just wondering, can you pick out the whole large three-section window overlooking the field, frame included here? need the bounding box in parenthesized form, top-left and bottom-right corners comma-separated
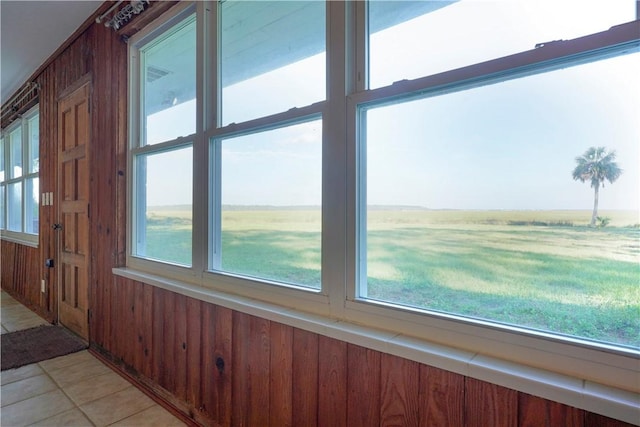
(126, 0, 640, 408)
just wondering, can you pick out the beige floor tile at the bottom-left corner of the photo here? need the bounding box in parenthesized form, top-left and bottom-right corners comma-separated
(0, 390, 73, 426)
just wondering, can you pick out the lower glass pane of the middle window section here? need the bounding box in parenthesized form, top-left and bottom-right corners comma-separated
(220, 120, 322, 289)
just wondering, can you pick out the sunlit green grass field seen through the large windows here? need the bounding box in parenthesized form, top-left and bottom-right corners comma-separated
(142, 208, 640, 347)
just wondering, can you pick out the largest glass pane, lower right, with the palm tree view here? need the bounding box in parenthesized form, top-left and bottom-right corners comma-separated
(360, 53, 640, 348)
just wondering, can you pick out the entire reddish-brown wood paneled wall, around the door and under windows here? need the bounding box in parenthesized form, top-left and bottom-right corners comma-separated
(2, 4, 636, 426)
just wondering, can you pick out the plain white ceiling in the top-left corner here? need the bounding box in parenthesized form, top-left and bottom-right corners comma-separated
(0, 0, 102, 104)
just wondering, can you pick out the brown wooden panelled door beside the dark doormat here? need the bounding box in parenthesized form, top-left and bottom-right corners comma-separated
(54, 83, 90, 340)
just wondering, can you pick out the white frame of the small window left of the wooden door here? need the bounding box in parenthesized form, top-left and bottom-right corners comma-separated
(0, 105, 40, 247)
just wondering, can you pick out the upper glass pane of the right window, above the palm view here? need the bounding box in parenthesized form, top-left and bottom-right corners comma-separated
(369, 0, 636, 88)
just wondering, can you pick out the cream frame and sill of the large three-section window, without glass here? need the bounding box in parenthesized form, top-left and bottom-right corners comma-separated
(114, 1, 640, 422)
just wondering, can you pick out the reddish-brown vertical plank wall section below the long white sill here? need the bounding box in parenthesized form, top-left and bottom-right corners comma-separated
(92, 278, 626, 427)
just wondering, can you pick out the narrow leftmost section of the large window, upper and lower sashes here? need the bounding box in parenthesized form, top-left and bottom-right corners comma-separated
(131, 11, 196, 267)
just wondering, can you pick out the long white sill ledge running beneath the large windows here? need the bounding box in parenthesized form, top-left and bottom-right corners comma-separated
(113, 268, 640, 424)
